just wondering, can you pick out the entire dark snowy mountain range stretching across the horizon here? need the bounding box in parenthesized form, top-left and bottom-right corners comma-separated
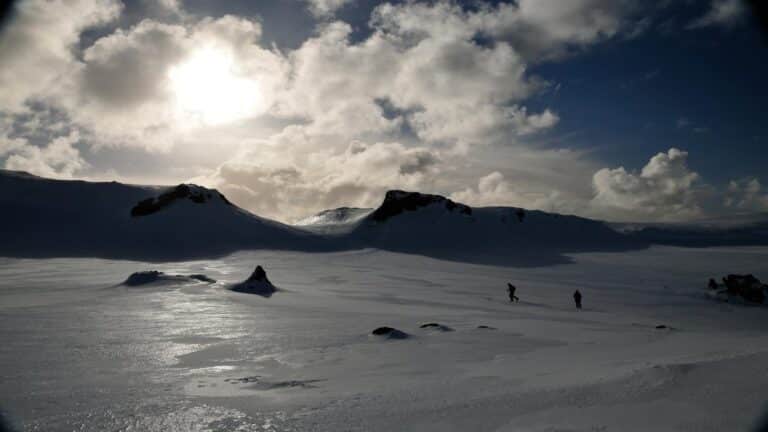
(0, 171, 768, 265)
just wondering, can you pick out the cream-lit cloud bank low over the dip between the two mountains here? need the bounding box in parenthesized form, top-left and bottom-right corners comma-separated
(193, 137, 441, 221)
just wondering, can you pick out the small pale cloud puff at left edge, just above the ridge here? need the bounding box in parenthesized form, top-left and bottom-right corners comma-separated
(5, 132, 88, 178)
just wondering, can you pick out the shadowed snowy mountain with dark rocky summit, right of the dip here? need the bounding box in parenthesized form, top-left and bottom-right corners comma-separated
(340, 190, 646, 265)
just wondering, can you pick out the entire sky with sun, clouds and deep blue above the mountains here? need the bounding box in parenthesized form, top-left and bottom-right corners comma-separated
(0, 0, 768, 223)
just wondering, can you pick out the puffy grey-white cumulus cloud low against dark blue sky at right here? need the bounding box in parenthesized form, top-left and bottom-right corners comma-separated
(590, 148, 703, 221)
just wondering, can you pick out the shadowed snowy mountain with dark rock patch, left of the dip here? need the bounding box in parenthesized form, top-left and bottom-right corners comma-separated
(0, 171, 327, 260)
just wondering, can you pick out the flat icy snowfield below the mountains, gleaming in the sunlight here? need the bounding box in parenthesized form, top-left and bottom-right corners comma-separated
(0, 247, 768, 432)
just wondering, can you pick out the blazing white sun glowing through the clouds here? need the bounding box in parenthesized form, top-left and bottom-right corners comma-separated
(168, 48, 264, 125)
